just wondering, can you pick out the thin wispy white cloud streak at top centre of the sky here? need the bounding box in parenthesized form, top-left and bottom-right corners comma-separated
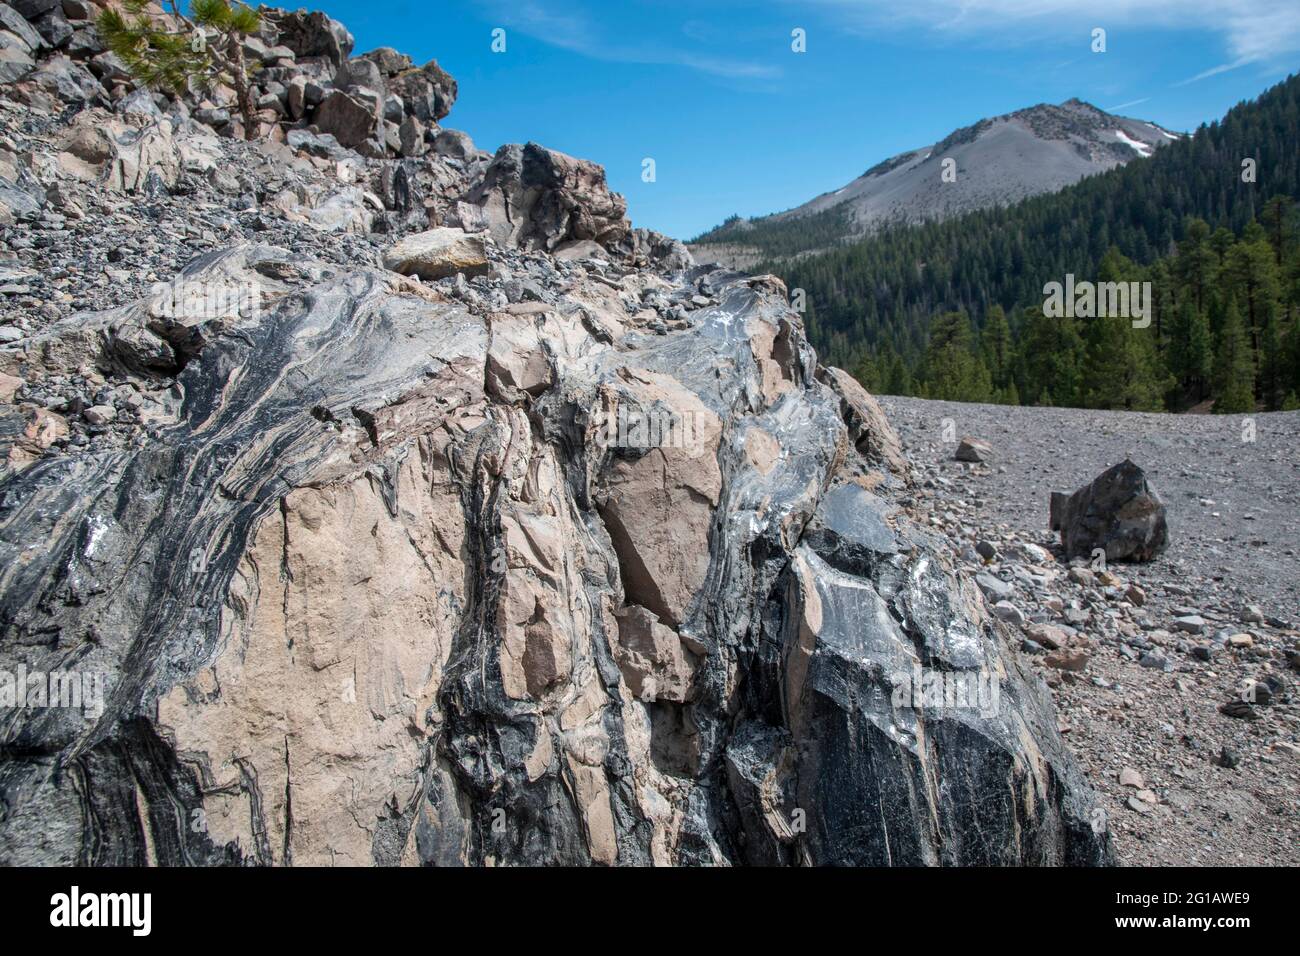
(485, 0, 781, 81)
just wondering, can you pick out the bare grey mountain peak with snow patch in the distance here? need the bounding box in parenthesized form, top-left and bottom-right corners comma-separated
(692, 99, 1179, 265)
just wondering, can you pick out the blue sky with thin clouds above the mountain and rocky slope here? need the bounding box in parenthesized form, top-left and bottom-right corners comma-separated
(309, 0, 1300, 238)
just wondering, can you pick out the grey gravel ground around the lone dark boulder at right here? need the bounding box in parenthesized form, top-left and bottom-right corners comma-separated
(880, 397, 1300, 866)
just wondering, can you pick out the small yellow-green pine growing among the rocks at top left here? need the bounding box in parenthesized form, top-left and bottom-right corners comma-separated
(98, 0, 261, 139)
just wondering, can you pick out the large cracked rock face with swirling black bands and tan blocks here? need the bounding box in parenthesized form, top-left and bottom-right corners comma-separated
(0, 234, 1110, 865)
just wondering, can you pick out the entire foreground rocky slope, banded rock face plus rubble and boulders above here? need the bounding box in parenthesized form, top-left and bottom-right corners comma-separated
(0, 0, 1113, 865)
